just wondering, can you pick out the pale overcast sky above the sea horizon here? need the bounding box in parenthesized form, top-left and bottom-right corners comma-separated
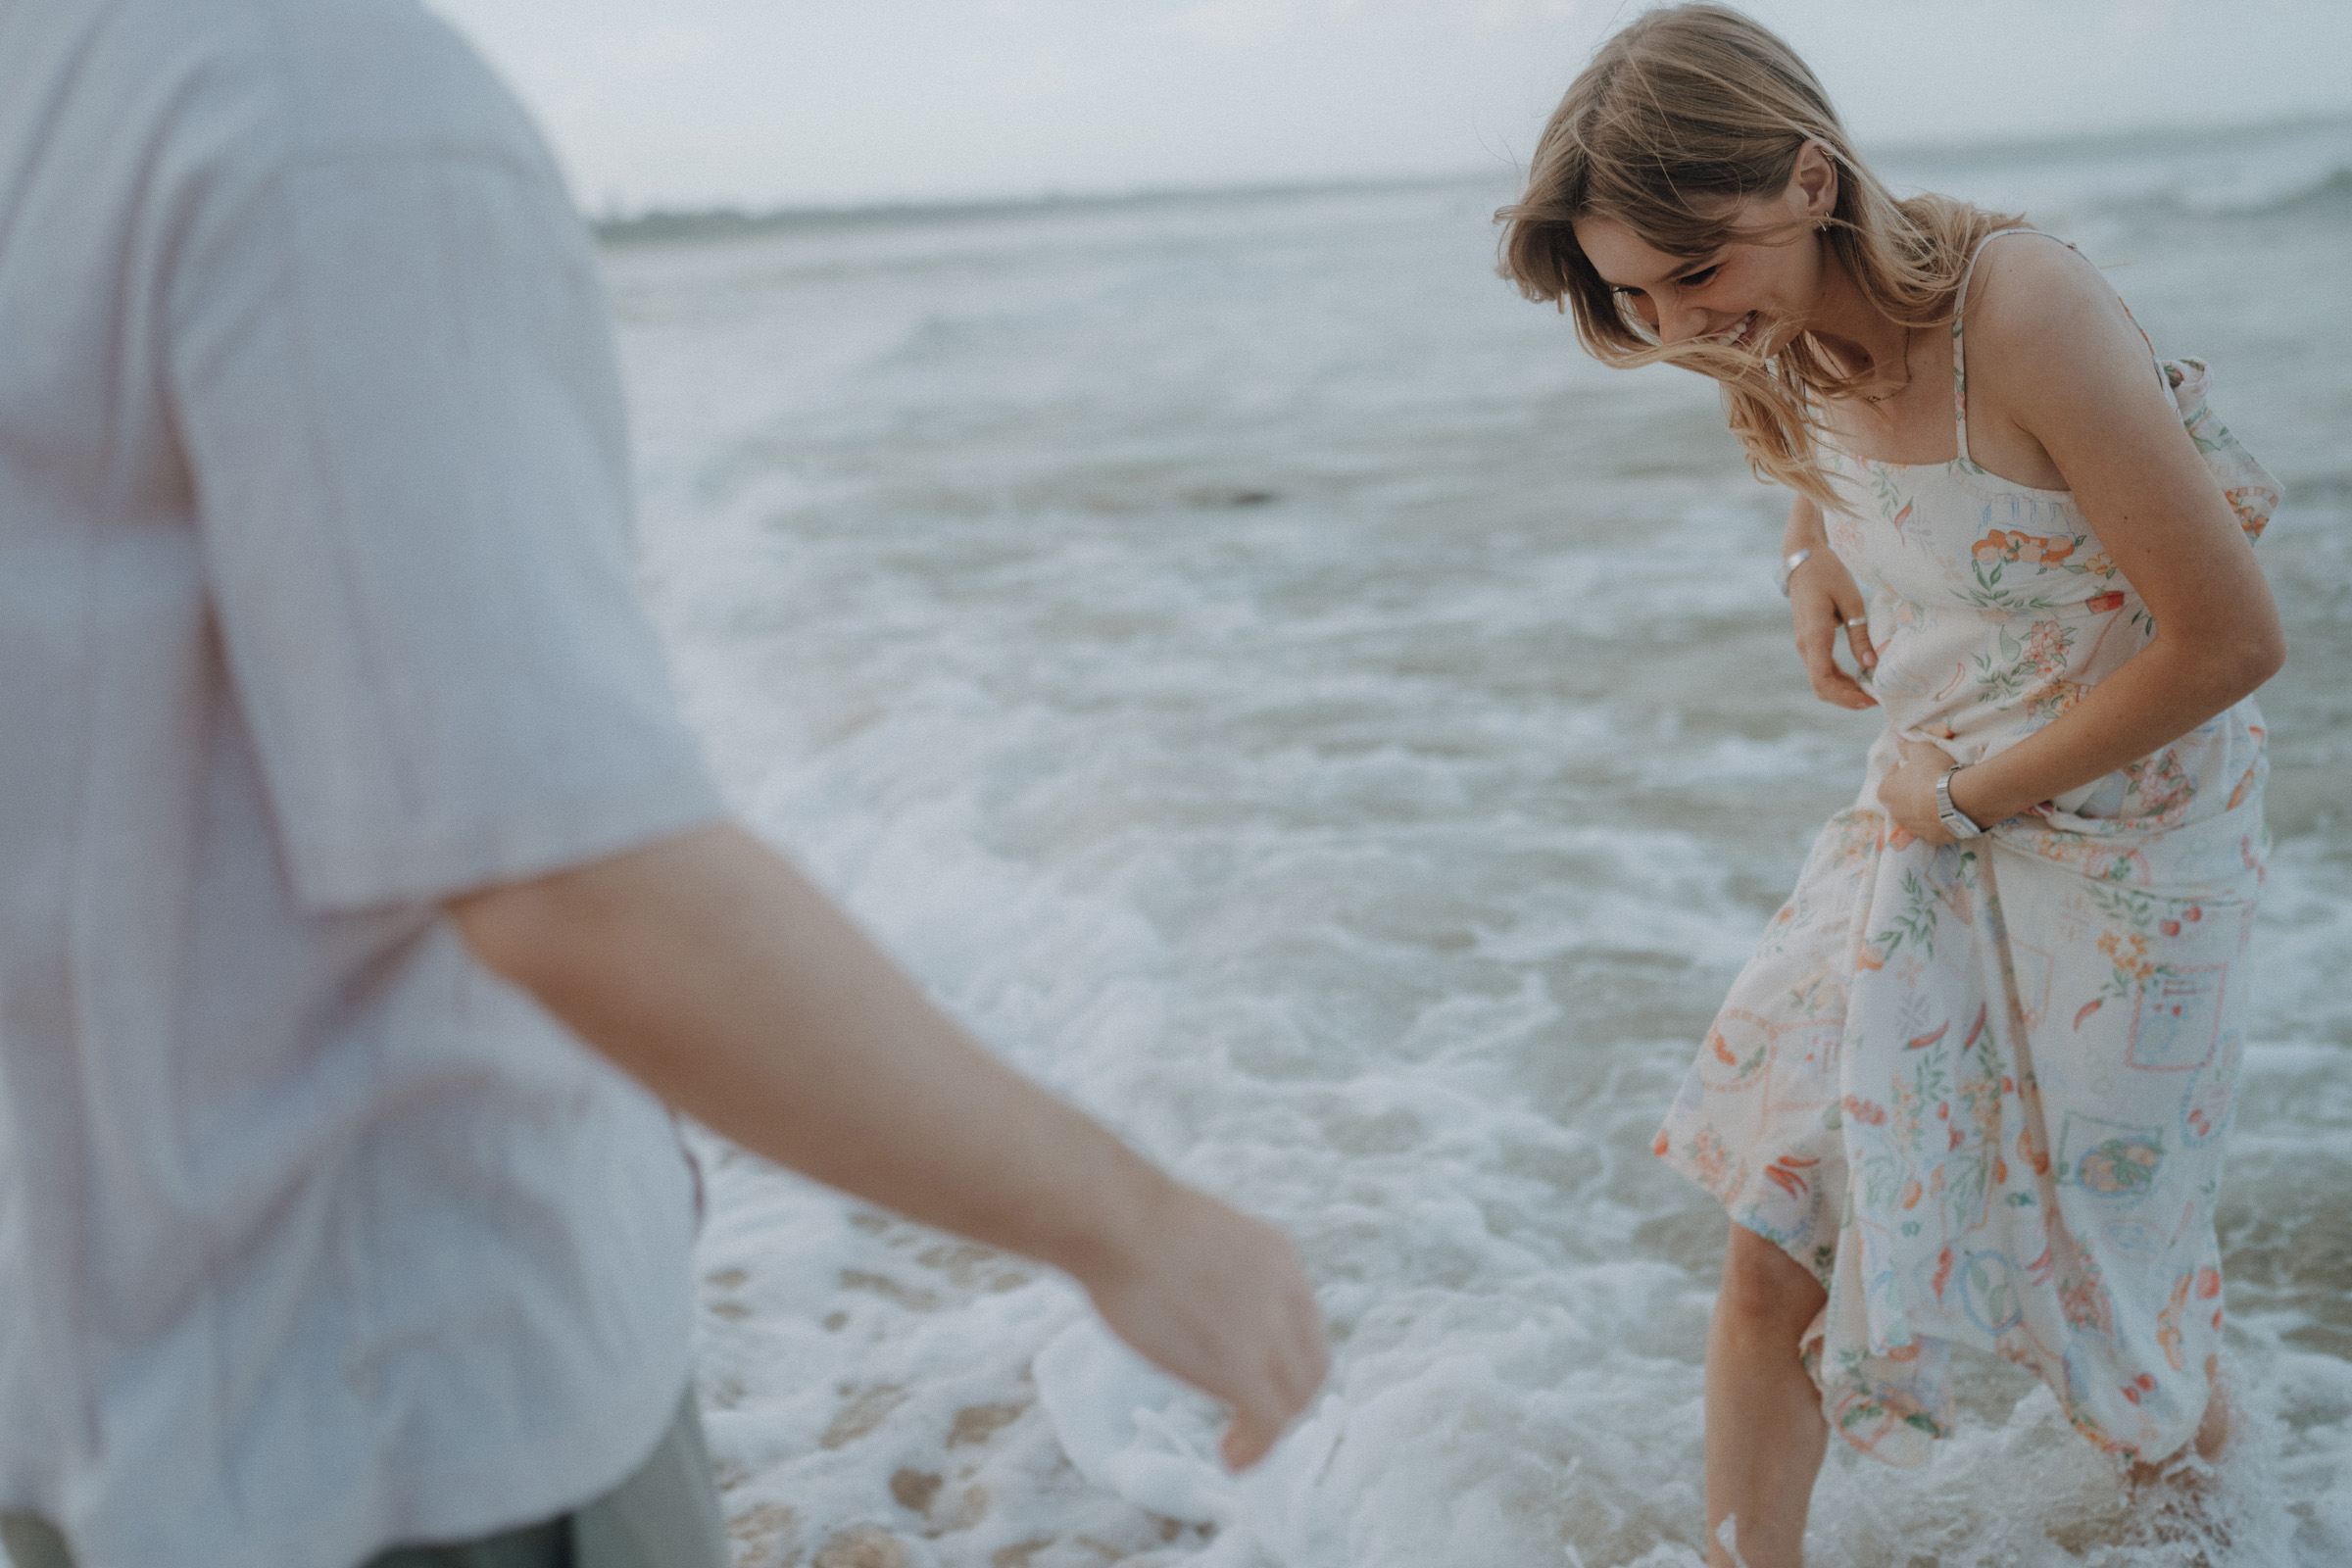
(428, 0, 2352, 209)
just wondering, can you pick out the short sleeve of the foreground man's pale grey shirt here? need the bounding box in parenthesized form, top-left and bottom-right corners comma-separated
(158, 120, 722, 909)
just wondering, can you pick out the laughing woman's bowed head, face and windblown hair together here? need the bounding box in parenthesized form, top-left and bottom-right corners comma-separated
(1503, 24, 2018, 508)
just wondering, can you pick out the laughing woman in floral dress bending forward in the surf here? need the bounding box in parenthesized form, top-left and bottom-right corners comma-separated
(1500, 5, 2283, 1568)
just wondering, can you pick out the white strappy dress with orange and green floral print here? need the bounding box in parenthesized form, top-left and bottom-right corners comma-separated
(1656, 230, 2279, 1464)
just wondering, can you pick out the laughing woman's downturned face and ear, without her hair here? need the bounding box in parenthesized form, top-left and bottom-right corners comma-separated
(1576, 143, 1837, 355)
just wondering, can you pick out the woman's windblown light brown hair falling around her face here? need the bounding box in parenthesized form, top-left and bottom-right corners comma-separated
(1495, 5, 2018, 511)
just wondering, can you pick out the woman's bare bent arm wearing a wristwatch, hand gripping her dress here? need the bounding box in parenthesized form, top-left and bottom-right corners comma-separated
(1880, 240, 2286, 844)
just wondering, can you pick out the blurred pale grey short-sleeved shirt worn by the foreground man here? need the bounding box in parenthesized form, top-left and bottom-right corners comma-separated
(0, 0, 719, 1568)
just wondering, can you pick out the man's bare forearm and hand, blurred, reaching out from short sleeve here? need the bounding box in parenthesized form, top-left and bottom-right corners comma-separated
(449, 825, 1327, 1467)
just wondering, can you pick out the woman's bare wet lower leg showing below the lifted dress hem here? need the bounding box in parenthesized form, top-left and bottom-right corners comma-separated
(1707, 1225, 1830, 1568)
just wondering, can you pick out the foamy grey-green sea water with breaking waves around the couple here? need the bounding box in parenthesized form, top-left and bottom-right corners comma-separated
(607, 124, 2352, 1568)
